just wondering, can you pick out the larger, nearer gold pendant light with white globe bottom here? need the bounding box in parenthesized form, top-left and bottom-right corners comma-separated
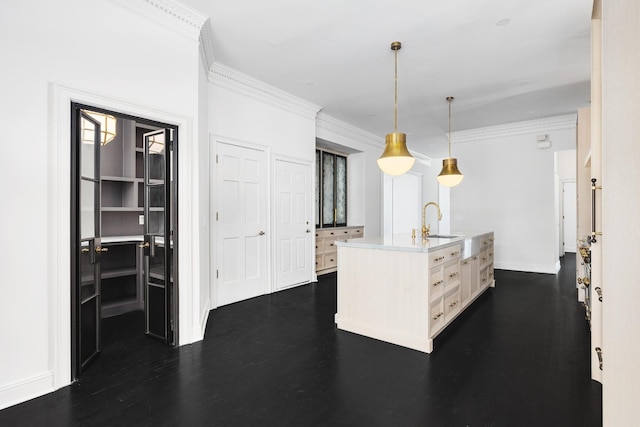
(378, 42, 416, 176)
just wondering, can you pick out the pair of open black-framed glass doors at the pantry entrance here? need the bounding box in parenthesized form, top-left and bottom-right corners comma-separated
(71, 104, 177, 377)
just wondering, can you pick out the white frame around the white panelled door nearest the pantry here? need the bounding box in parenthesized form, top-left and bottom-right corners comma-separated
(208, 134, 273, 310)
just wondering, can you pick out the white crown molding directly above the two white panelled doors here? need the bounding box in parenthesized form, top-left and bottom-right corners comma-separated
(209, 62, 322, 119)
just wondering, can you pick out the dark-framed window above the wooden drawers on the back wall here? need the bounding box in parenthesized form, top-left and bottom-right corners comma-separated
(316, 150, 347, 228)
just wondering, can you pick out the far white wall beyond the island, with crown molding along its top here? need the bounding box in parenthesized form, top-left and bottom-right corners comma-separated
(451, 115, 576, 273)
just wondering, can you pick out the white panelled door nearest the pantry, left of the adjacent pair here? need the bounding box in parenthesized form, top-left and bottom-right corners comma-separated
(212, 142, 268, 306)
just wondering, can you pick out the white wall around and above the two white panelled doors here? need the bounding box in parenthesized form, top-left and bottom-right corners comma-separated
(207, 64, 320, 308)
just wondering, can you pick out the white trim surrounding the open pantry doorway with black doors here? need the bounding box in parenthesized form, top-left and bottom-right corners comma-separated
(51, 82, 198, 390)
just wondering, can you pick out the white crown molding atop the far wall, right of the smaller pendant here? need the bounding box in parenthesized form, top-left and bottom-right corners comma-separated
(451, 114, 578, 144)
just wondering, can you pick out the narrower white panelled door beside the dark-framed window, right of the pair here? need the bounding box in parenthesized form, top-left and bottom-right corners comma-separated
(275, 160, 314, 289)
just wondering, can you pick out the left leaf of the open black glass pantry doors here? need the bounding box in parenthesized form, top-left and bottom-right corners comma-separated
(72, 109, 103, 377)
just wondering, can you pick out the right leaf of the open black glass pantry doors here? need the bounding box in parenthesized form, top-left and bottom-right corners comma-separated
(142, 129, 174, 343)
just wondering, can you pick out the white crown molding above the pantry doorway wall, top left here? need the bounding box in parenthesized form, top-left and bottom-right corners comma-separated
(112, 0, 208, 40)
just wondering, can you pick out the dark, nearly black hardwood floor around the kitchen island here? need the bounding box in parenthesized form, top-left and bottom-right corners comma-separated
(0, 254, 602, 427)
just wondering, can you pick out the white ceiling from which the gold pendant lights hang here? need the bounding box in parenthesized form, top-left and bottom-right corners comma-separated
(182, 0, 592, 158)
